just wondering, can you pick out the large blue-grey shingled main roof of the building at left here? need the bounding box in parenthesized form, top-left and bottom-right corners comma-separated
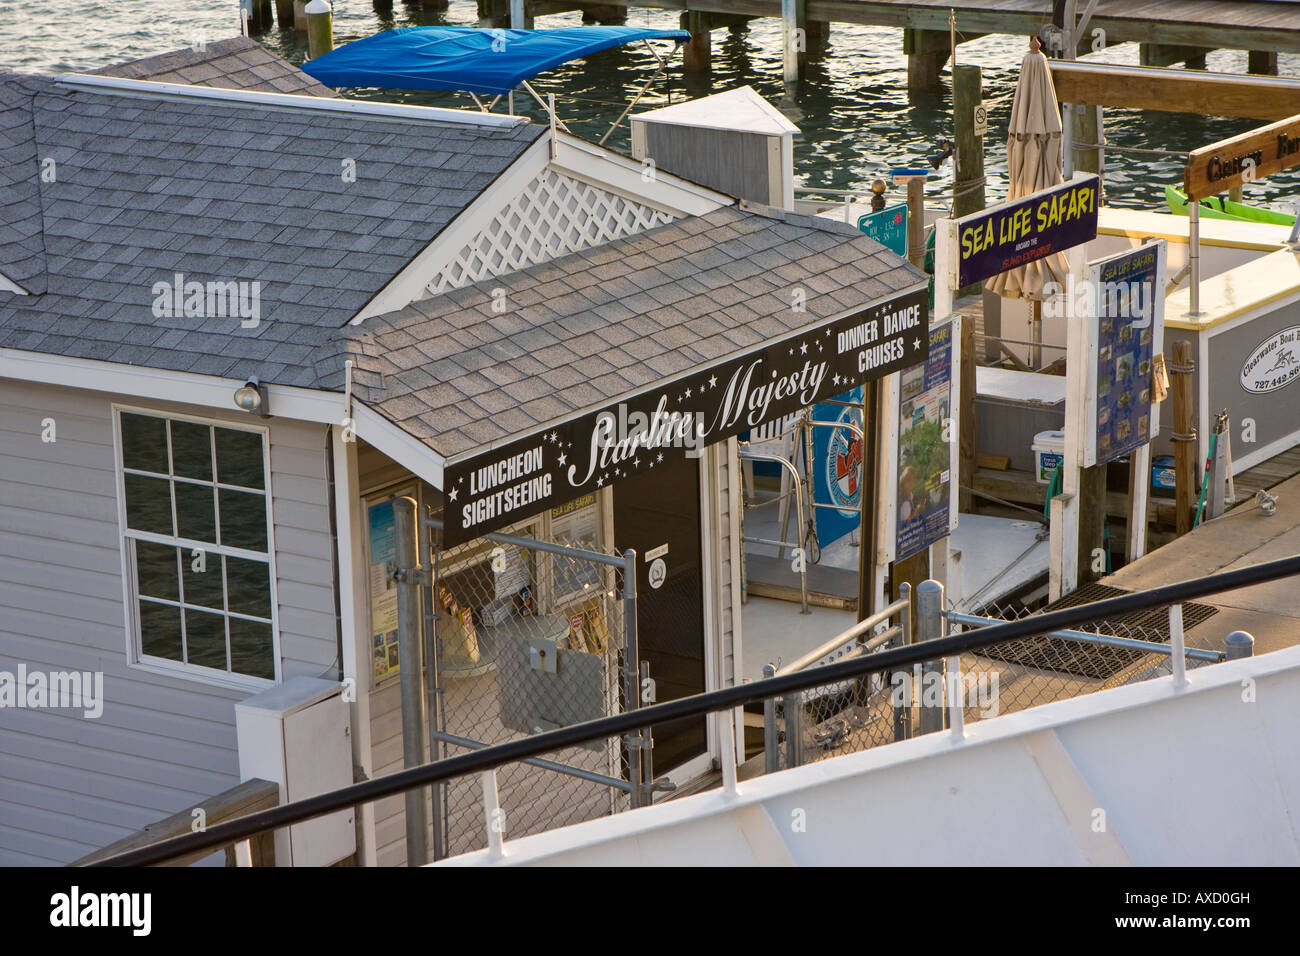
(0, 73, 545, 385)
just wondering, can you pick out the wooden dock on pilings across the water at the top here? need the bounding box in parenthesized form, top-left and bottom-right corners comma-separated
(512, 0, 1300, 88)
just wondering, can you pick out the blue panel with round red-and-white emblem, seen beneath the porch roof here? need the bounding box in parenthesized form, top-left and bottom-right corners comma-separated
(813, 385, 862, 548)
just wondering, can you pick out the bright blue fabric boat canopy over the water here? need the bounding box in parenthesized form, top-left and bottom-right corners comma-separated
(303, 26, 690, 94)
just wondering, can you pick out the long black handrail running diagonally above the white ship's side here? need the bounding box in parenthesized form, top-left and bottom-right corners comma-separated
(92, 554, 1300, 866)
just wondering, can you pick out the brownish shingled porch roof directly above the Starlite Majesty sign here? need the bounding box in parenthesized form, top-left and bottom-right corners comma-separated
(317, 203, 926, 458)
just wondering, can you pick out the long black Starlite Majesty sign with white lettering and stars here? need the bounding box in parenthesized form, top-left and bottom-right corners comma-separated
(443, 285, 930, 546)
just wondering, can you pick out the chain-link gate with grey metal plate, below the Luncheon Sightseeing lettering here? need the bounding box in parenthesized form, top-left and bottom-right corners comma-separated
(408, 512, 649, 857)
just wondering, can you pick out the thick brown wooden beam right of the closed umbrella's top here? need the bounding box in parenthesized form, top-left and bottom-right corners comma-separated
(1048, 60, 1300, 120)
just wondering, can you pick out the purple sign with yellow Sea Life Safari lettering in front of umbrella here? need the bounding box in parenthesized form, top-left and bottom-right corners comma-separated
(953, 176, 1101, 289)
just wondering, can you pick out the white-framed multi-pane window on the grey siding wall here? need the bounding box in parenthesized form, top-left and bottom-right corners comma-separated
(111, 402, 283, 691)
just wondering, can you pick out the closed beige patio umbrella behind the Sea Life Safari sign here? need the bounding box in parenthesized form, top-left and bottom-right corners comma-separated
(987, 38, 1069, 302)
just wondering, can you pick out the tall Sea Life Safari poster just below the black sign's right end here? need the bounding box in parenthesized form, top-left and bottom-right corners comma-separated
(894, 323, 953, 561)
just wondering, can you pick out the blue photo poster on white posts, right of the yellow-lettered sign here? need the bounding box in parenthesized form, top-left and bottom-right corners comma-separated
(1086, 245, 1164, 464)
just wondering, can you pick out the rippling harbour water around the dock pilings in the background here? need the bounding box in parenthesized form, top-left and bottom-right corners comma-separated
(0, 0, 1300, 209)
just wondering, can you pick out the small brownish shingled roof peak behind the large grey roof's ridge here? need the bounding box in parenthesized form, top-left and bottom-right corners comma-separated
(91, 36, 334, 96)
